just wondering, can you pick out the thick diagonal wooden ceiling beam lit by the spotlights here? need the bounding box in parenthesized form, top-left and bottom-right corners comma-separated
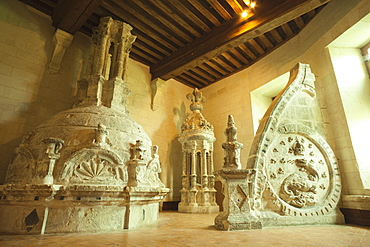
(151, 0, 330, 80)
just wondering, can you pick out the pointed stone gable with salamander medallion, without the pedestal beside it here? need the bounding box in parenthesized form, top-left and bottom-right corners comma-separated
(247, 64, 343, 225)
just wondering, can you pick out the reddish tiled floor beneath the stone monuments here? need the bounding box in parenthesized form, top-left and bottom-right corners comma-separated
(0, 211, 370, 247)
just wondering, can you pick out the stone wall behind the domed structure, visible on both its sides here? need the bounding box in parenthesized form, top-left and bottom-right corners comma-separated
(0, 1, 192, 200)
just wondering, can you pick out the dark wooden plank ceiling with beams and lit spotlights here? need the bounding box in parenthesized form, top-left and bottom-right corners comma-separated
(21, 0, 330, 88)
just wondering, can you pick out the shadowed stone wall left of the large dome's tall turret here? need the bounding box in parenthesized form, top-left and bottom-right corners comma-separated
(0, 1, 90, 183)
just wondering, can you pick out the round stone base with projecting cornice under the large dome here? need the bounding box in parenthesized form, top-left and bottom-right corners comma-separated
(0, 185, 168, 234)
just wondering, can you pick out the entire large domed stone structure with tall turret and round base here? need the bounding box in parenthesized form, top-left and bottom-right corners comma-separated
(0, 17, 169, 234)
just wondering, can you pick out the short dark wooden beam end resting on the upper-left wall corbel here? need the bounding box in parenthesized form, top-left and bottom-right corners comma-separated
(51, 0, 102, 34)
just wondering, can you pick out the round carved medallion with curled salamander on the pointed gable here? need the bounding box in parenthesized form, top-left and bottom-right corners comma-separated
(266, 133, 340, 215)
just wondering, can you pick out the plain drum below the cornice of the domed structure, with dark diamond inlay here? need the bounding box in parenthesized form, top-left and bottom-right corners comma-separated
(0, 203, 159, 234)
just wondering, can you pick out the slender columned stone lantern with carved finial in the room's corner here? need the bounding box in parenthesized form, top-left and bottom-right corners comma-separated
(179, 88, 219, 213)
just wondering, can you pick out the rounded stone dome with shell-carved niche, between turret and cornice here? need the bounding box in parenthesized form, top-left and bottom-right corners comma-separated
(6, 106, 152, 184)
